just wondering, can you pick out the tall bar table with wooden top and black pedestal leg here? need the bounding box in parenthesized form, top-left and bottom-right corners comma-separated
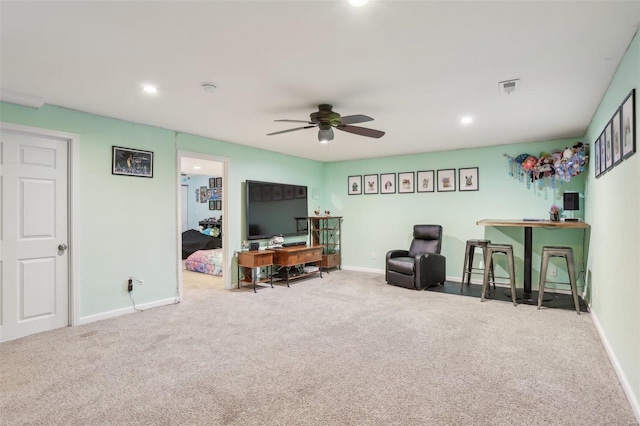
(476, 219, 589, 304)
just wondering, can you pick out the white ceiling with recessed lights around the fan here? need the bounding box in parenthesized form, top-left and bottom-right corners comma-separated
(0, 0, 640, 161)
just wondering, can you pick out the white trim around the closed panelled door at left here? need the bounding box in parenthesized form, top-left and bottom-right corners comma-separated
(0, 122, 80, 327)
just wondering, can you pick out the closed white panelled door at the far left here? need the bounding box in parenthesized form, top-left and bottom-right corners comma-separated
(0, 129, 69, 341)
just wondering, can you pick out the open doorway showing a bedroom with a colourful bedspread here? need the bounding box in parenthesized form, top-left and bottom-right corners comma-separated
(177, 151, 231, 298)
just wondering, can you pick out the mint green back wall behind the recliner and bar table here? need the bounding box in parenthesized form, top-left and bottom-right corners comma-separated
(321, 139, 588, 288)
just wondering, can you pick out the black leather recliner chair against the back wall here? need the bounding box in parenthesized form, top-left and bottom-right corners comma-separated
(385, 225, 446, 290)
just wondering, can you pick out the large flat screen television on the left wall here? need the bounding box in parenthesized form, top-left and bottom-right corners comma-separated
(246, 180, 309, 240)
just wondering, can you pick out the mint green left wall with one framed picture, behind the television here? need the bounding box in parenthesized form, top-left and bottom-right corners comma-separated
(0, 103, 323, 318)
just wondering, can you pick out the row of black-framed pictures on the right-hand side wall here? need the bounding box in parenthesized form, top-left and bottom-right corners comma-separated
(594, 89, 636, 178)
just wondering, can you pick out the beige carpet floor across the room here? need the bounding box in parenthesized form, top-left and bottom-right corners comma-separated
(0, 270, 638, 425)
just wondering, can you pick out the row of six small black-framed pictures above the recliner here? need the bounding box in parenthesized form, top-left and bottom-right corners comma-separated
(347, 167, 479, 195)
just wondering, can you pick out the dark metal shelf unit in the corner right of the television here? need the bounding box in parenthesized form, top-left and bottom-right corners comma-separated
(308, 216, 342, 269)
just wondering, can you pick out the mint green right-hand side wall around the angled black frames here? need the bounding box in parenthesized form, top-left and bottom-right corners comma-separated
(586, 33, 640, 410)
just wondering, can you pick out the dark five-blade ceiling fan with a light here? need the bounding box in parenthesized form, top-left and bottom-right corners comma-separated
(267, 104, 384, 143)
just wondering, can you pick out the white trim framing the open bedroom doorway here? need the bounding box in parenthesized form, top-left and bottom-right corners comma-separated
(176, 150, 233, 300)
